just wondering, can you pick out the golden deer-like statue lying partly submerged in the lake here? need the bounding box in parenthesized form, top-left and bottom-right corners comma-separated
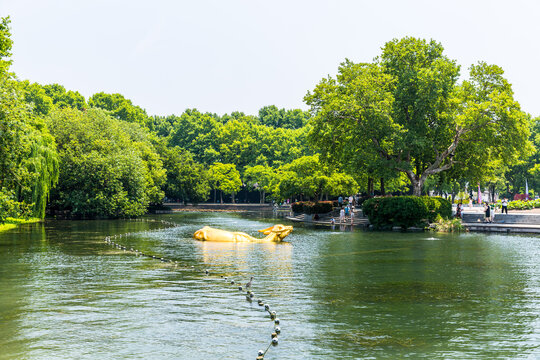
(193, 224, 293, 242)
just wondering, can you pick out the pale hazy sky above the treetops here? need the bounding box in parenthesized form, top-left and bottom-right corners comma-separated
(0, 0, 540, 116)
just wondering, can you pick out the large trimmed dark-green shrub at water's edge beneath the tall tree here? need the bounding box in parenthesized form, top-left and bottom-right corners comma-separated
(363, 196, 452, 228)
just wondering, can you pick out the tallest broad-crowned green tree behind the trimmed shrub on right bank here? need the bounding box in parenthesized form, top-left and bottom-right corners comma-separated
(305, 37, 530, 195)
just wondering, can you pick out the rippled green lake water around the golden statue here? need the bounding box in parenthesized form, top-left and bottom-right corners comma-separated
(0, 213, 540, 359)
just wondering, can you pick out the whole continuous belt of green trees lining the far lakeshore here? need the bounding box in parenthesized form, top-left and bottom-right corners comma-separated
(0, 18, 540, 222)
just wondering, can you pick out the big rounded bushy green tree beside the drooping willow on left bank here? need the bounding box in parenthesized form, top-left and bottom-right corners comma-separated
(47, 109, 165, 217)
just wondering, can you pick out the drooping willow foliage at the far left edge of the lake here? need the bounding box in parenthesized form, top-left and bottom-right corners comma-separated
(0, 18, 58, 221)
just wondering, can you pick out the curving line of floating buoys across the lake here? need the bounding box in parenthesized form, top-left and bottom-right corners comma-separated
(100, 219, 281, 360)
